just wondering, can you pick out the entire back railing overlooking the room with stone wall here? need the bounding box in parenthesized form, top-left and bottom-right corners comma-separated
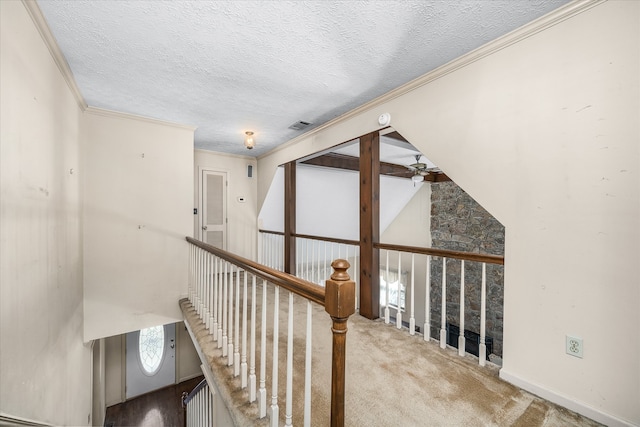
(260, 230, 504, 366)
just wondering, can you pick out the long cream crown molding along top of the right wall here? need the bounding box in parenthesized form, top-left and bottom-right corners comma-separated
(258, 0, 608, 159)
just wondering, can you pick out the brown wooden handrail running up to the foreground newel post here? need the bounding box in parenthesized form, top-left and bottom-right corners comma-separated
(186, 237, 325, 306)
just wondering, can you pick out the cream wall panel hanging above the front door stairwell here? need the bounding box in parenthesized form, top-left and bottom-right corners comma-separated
(82, 109, 193, 340)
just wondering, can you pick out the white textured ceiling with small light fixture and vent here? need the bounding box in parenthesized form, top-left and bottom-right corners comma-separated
(38, 0, 567, 156)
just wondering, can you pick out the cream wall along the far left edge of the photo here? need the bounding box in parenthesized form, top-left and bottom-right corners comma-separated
(0, 1, 92, 425)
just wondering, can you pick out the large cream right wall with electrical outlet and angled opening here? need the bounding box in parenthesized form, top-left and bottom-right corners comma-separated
(259, 1, 640, 425)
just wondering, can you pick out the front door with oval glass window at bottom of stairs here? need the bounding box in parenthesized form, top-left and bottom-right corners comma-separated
(125, 323, 176, 399)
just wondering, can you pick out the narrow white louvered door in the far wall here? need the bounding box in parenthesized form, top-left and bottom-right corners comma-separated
(200, 170, 227, 249)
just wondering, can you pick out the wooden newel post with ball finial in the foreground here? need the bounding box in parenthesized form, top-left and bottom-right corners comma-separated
(324, 259, 356, 427)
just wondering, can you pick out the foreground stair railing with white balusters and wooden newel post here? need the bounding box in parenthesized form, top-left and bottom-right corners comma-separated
(186, 237, 355, 427)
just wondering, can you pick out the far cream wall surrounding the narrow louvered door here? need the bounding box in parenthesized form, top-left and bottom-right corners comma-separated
(193, 150, 258, 259)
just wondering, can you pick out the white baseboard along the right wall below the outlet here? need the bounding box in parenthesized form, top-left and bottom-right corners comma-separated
(500, 368, 637, 427)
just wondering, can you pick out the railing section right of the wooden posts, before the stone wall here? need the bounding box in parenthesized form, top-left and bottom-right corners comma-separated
(378, 244, 504, 366)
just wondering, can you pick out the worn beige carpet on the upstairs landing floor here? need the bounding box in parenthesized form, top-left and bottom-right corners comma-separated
(180, 286, 599, 427)
